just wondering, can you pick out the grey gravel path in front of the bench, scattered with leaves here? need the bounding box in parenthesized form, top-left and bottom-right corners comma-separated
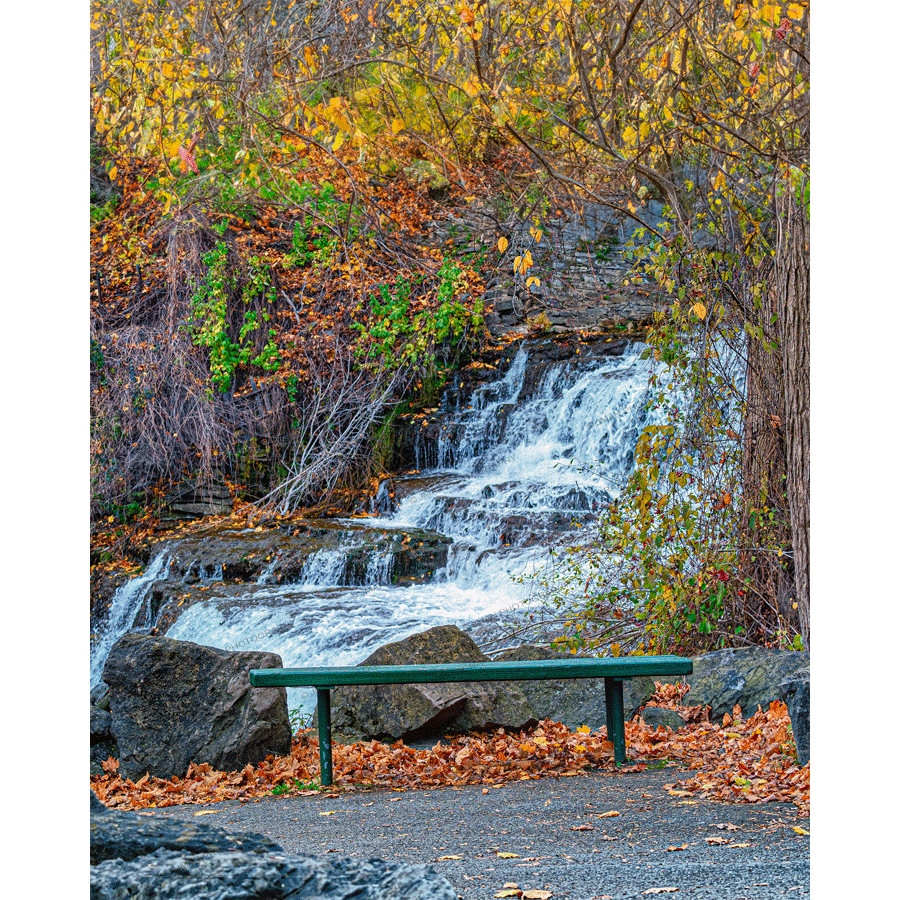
(152, 768, 810, 900)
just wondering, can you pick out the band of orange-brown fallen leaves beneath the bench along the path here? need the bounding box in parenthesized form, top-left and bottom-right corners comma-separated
(91, 694, 810, 816)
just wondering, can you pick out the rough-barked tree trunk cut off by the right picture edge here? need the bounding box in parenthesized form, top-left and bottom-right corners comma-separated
(775, 179, 810, 650)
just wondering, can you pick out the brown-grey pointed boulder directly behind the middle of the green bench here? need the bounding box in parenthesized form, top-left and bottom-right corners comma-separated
(331, 625, 537, 744)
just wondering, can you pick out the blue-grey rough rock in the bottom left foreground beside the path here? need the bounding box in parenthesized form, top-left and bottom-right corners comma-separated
(91, 792, 457, 900)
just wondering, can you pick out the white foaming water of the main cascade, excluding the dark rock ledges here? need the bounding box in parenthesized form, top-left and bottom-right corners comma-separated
(92, 344, 650, 715)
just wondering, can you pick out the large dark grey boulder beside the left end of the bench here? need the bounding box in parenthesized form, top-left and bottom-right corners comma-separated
(103, 634, 291, 778)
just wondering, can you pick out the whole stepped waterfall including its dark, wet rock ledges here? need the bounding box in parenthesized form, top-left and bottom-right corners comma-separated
(91, 338, 650, 716)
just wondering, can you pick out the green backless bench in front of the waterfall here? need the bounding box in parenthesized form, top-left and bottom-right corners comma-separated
(250, 656, 694, 786)
